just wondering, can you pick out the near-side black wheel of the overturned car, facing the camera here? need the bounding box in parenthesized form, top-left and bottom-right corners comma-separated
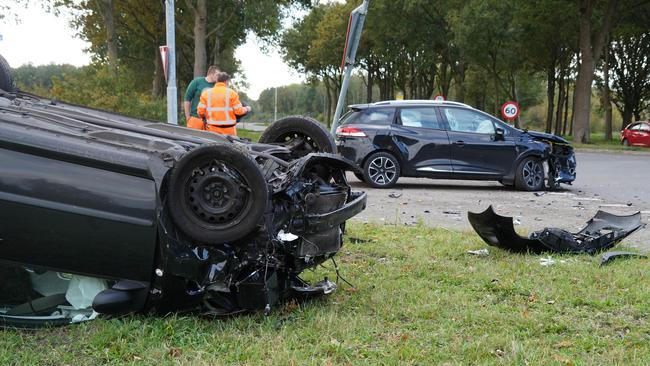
(167, 144, 269, 244)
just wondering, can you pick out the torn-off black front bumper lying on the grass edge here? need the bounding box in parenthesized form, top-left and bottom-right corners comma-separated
(467, 206, 645, 254)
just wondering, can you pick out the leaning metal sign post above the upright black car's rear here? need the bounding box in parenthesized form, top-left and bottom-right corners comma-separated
(331, 0, 370, 135)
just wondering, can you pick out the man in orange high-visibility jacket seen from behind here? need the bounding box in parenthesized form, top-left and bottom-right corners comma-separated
(197, 72, 251, 136)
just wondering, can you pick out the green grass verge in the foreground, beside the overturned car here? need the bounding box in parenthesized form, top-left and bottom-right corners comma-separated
(0, 223, 650, 365)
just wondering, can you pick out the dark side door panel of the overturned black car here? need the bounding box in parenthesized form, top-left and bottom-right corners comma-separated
(0, 144, 156, 281)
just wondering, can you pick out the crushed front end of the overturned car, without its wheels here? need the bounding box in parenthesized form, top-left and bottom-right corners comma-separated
(137, 150, 366, 315)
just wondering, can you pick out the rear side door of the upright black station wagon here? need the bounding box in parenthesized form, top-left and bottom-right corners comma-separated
(391, 106, 452, 176)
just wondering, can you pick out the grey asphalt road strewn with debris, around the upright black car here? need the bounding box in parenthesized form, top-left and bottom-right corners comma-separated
(348, 152, 650, 252)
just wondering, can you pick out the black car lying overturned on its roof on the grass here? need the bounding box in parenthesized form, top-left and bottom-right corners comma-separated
(0, 59, 366, 327)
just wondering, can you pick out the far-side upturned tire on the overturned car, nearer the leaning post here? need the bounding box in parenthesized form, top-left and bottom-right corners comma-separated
(259, 116, 336, 158)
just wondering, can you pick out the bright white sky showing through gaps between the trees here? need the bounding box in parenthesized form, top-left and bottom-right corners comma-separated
(0, 0, 304, 99)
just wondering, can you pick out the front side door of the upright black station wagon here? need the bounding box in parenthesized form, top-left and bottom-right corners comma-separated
(440, 106, 517, 176)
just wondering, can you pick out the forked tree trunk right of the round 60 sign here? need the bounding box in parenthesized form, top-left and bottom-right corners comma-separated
(573, 0, 617, 143)
